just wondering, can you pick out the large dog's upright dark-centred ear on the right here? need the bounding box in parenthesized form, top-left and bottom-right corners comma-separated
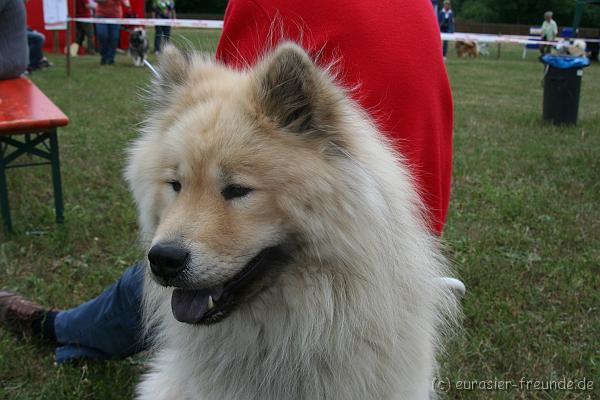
(254, 42, 339, 133)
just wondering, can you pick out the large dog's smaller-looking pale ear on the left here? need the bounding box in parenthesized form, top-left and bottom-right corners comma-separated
(151, 44, 193, 105)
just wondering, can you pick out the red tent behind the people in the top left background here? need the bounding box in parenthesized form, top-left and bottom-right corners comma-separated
(26, 0, 145, 53)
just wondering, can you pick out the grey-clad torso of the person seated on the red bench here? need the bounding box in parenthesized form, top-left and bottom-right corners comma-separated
(0, 0, 29, 79)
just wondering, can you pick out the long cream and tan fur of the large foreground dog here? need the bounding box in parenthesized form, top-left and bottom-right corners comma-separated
(126, 43, 457, 400)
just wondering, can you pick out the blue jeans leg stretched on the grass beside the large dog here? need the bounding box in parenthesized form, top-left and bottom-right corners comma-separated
(54, 262, 147, 363)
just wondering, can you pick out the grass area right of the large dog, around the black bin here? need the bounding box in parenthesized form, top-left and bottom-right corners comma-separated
(442, 44, 600, 399)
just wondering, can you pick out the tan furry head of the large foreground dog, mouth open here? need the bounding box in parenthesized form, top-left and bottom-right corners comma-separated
(126, 43, 345, 323)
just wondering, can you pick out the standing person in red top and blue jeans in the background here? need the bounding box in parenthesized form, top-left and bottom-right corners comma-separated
(96, 0, 130, 65)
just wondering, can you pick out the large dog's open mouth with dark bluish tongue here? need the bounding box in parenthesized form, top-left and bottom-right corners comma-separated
(171, 246, 285, 325)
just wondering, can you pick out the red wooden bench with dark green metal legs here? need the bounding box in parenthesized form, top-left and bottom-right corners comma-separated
(0, 77, 69, 232)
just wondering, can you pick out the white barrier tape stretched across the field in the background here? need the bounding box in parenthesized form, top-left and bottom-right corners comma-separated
(71, 18, 600, 45)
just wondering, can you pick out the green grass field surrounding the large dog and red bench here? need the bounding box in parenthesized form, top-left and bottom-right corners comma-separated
(0, 31, 600, 399)
